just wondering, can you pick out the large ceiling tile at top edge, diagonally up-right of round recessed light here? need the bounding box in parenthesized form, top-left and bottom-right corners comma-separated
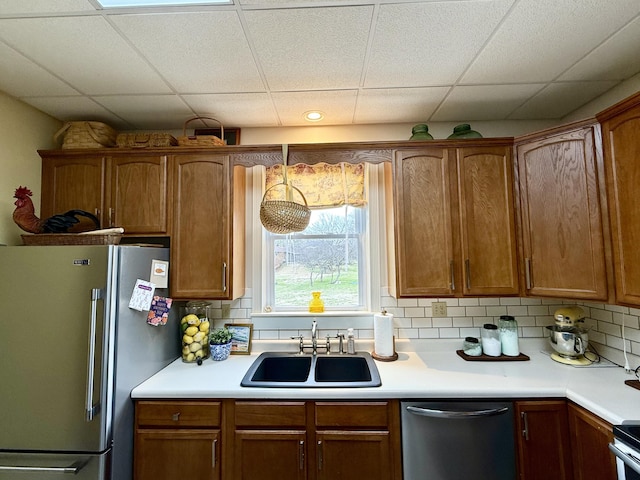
(364, 0, 513, 88)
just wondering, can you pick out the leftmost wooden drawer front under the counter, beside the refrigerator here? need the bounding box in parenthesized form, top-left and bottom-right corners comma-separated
(136, 401, 222, 427)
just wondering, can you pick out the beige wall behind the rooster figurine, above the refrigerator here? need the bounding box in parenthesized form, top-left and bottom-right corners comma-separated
(0, 92, 61, 245)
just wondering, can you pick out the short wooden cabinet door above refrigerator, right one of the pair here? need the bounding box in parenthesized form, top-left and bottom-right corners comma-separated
(107, 155, 167, 234)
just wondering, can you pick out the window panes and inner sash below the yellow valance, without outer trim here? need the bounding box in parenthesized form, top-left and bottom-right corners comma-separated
(265, 206, 367, 311)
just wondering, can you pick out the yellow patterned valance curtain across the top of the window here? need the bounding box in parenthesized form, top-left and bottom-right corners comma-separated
(265, 163, 367, 208)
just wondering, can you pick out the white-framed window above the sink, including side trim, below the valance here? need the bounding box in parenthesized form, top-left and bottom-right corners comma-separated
(252, 164, 393, 316)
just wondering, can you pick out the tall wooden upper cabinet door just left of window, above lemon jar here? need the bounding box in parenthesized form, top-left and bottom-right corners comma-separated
(170, 155, 232, 299)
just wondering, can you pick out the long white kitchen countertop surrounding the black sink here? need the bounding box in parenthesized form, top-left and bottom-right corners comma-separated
(131, 339, 640, 425)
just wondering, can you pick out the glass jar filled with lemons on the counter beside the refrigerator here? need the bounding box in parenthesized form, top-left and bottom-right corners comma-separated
(180, 301, 210, 363)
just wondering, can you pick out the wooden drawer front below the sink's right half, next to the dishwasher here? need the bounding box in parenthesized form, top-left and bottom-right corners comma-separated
(315, 402, 389, 428)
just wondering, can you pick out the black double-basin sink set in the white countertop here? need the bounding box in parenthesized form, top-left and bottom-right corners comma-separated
(240, 352, 382, 388)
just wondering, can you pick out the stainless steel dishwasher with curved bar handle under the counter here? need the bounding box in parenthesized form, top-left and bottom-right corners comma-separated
(400, 401, 517, 480)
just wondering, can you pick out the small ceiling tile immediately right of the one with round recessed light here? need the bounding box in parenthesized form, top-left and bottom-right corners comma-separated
(355, 87, 449, 124)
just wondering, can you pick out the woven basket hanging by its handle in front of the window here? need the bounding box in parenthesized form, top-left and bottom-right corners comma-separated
(260, 183, 311, 234)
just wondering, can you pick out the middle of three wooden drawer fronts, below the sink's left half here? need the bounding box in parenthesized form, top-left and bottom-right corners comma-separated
(235, 402, 306, 428)
